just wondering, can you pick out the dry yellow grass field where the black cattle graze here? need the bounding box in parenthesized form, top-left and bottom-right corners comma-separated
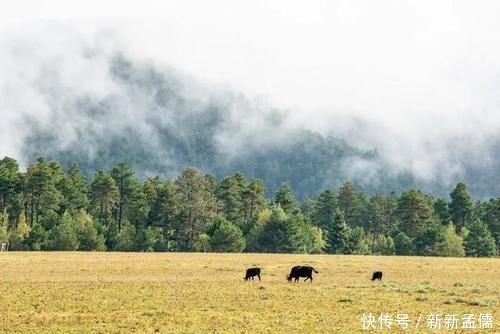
(0, 252, 500, 333)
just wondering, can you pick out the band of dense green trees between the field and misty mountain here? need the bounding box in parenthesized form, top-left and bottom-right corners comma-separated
(0, 157, 500, 257)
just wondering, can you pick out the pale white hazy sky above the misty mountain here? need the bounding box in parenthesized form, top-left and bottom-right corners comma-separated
(0, 0, 500, 181)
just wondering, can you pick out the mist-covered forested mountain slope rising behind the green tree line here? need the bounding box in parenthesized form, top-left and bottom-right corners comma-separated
(15, 52, 500, 199)
